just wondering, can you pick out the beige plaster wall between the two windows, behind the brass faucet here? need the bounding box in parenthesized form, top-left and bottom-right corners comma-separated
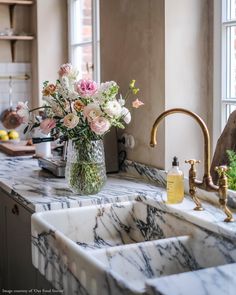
(101, 0, 212, 177)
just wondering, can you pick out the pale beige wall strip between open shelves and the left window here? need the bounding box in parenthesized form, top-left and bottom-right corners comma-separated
(33, 0, 68, 105)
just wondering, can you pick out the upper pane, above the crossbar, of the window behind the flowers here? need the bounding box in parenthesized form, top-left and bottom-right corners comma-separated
(71, 0, 92, 44)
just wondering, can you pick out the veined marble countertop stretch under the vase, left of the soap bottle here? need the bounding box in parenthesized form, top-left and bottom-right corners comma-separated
(0, 157, 166, 212)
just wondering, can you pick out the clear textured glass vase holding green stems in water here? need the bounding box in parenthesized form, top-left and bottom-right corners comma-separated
(65, 140, 106, 195)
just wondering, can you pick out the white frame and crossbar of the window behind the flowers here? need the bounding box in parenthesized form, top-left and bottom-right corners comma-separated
(67, 0, 101, 83)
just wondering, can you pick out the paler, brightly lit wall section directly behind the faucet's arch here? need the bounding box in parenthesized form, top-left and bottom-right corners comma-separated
(165, 0, 212, 177)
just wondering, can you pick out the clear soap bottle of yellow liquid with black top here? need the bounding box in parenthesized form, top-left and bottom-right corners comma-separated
(167, 157, 184, 204)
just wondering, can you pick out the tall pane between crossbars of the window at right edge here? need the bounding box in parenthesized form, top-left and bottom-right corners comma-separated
(226, 26, 236, 98)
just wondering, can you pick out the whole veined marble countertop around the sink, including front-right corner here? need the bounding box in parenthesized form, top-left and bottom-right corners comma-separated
(0, 155, 236, 295)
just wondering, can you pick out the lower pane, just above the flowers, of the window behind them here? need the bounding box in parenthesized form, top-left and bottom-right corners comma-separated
(73, 44, 93, 79)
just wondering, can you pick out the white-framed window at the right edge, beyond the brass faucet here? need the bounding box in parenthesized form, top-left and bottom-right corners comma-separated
(221, 0, 236, 127)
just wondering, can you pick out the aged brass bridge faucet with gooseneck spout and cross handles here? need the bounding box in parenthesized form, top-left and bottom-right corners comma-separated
(150, 108, 234, 222)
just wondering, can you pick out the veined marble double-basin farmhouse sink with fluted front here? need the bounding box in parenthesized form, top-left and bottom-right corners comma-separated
(32, 199, 236, 295)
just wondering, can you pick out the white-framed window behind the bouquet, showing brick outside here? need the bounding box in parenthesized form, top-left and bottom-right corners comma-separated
(68, 0, 100, 82)
